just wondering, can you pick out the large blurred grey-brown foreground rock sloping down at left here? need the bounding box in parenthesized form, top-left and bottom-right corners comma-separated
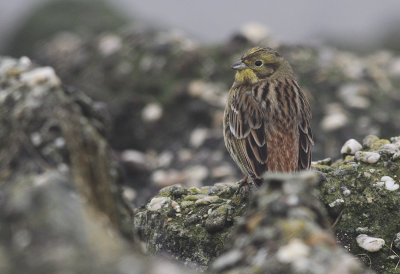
(0, 57, 192, 274)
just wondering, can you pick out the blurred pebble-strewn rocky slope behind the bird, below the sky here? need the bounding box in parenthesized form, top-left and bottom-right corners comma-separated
(6, 3, 400, 208)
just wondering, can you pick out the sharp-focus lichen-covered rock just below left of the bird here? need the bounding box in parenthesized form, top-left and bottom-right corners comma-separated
(134, 184, 248, 270)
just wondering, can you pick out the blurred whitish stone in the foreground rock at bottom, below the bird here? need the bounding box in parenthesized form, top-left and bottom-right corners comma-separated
(276, 239, 310, 263)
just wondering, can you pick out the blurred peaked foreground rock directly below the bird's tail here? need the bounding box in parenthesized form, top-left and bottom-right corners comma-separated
(211, 172, 368, 273)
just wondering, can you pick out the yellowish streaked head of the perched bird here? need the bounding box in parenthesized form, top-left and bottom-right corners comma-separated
(232, 47, 293, 84)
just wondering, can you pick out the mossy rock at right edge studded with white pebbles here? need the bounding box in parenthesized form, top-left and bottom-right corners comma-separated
(314, 135, 400, 273)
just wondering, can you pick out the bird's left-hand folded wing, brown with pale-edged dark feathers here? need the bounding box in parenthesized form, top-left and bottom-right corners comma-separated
(228, 87, 268, 177)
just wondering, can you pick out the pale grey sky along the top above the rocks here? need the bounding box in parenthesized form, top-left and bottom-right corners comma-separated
(0, 0, 400, 48)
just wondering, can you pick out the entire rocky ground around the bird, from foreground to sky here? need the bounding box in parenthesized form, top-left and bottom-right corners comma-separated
(0, 1, 400, 273)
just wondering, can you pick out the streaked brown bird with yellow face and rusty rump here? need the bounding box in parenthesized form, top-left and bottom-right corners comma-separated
(223, 47, 314, 191)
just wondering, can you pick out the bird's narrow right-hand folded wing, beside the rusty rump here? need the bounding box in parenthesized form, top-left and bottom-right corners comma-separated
(296, 83, 314, 170)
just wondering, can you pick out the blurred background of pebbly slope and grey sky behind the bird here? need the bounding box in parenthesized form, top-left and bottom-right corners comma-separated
(0, 0, 400, 204)
